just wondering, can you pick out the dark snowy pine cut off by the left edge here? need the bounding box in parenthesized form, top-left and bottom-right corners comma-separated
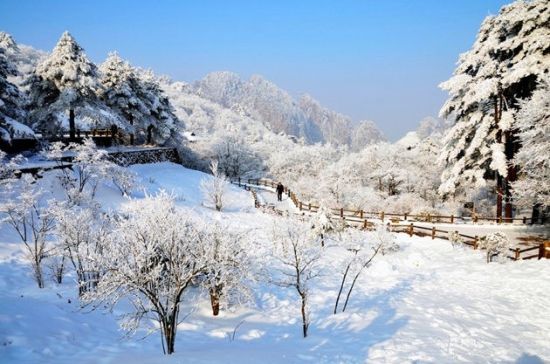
(0, 38, 29, 142)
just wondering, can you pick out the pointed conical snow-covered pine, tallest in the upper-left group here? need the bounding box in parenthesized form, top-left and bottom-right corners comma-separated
(27, 32, 120, 139)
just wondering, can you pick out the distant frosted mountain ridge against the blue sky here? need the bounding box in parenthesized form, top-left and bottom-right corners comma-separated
(191, 71, 386, 150)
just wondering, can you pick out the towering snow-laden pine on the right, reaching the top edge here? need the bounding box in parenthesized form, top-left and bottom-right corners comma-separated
(439, 0, 550, 217)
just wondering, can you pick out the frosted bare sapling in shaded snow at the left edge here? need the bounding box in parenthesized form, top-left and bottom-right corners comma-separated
(0, 174, 55, 288)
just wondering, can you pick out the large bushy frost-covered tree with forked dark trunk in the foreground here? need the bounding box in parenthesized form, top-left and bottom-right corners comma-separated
(83, 192, 207, 354)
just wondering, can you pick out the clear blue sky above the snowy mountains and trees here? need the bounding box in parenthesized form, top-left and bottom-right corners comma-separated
(0, 0, 510, 140)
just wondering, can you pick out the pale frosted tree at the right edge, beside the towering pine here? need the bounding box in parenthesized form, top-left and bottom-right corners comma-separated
(513, 74, 550, 206)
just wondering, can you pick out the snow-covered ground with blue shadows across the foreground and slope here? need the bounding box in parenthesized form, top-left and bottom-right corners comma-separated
(0, 163, 550, 363)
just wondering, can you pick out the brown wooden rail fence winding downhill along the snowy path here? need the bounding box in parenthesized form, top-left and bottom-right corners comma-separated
(231, 178, 550, 260)
